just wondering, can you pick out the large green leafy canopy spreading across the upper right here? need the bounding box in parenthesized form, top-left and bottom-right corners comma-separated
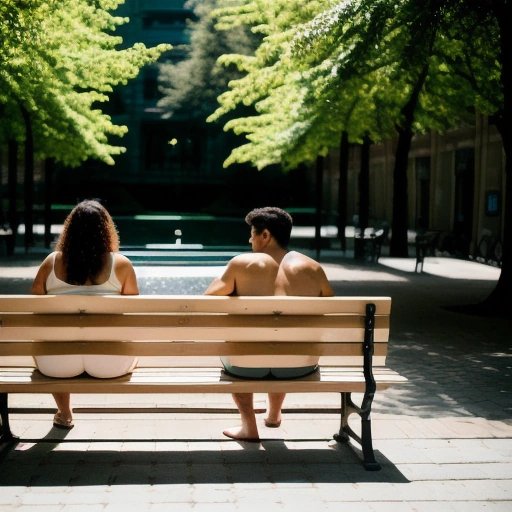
(209, 0, 499, 172)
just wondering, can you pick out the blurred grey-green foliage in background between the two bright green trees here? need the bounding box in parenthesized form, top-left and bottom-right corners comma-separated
(158, 0, 258, 120)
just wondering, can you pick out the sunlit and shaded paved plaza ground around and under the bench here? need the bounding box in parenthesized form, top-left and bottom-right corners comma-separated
(0, 254, 512, 512)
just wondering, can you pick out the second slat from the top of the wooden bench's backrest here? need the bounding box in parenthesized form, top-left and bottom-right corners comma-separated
(0, 314, 389, 343)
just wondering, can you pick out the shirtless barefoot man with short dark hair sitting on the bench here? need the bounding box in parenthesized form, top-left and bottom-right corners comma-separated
(205, 207, 334, 442)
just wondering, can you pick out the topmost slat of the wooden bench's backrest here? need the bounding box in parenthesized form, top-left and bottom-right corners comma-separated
(0, 295, 391, 315)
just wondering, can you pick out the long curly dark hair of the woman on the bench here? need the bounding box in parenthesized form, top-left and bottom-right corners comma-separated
(56, 200, 119, 285)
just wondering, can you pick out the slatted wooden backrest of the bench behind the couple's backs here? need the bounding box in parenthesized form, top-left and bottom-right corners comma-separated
(0, 295, 391, 366)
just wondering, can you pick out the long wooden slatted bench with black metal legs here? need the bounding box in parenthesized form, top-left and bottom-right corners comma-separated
(0, 295, 406, 470)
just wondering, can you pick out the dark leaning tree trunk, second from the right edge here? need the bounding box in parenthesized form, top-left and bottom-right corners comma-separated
(389, 64, 428, 258)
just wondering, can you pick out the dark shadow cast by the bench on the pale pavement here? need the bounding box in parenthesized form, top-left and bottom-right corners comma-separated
(0, 440, 409, 487)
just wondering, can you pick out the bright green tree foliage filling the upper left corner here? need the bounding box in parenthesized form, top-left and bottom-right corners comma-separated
(0, 0, 170, 165)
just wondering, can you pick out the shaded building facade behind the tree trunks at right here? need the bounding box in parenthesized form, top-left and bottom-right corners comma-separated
(326, 115, 505, 255)
